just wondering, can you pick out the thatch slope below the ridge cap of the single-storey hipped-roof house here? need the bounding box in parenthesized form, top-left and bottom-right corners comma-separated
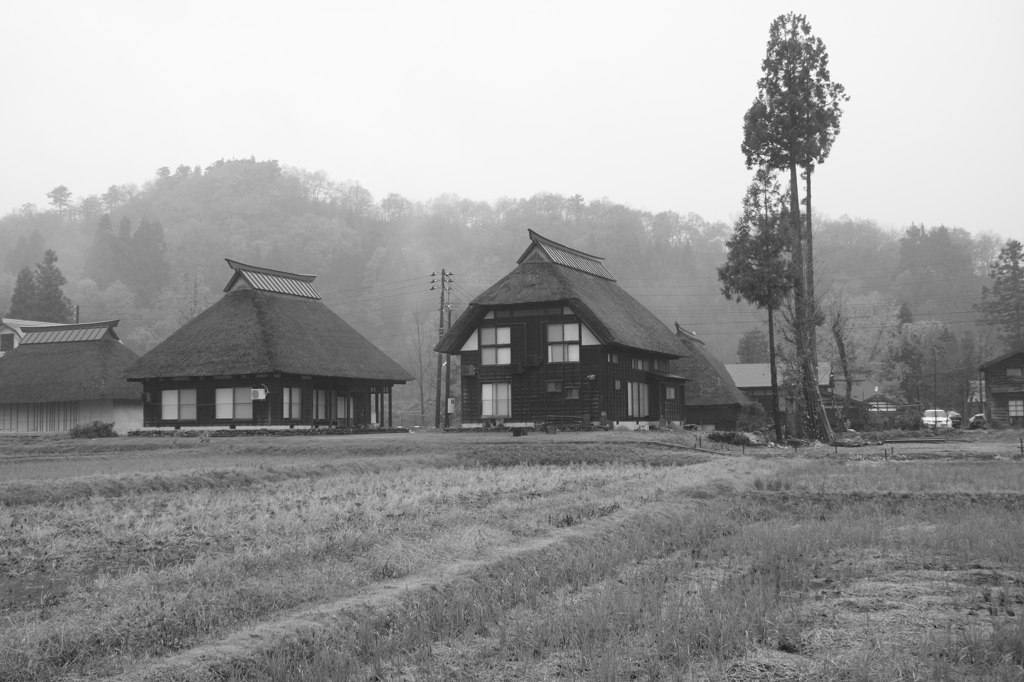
(127, 289, 413, 383)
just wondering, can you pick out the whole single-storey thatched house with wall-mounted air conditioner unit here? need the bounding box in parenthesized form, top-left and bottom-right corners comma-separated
(127, 260, 413, 429)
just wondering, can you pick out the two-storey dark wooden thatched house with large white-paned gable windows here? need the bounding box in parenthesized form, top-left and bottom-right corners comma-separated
(436, 230, 686, 428)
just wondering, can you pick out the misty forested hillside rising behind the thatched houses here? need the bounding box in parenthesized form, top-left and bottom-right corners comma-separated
(0, 159, 999, 373)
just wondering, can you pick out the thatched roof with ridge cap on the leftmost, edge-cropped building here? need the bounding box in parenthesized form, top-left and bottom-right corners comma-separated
(0, 321, 142, 402)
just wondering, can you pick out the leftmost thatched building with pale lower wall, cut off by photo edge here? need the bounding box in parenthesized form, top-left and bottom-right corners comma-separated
(0, 319, 142, 433)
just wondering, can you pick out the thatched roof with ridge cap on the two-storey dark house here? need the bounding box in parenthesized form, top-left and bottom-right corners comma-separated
(435, 230, 685, 357)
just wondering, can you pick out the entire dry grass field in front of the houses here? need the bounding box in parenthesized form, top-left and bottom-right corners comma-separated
(0, 432, 1024, 682)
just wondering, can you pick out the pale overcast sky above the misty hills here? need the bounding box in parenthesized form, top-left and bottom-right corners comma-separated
(0, 0, 1024, 239)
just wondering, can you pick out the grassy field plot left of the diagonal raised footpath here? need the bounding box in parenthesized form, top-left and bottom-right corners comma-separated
(0, 436, 720, 680)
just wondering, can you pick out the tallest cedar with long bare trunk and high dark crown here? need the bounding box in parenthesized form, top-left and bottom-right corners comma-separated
(741, 12, 849, 436)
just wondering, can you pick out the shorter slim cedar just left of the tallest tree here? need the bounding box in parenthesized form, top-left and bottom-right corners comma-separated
(718, 168, 794, 442)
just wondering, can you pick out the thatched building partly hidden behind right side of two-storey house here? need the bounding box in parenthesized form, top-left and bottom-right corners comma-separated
(669, 323, 749, 431)
